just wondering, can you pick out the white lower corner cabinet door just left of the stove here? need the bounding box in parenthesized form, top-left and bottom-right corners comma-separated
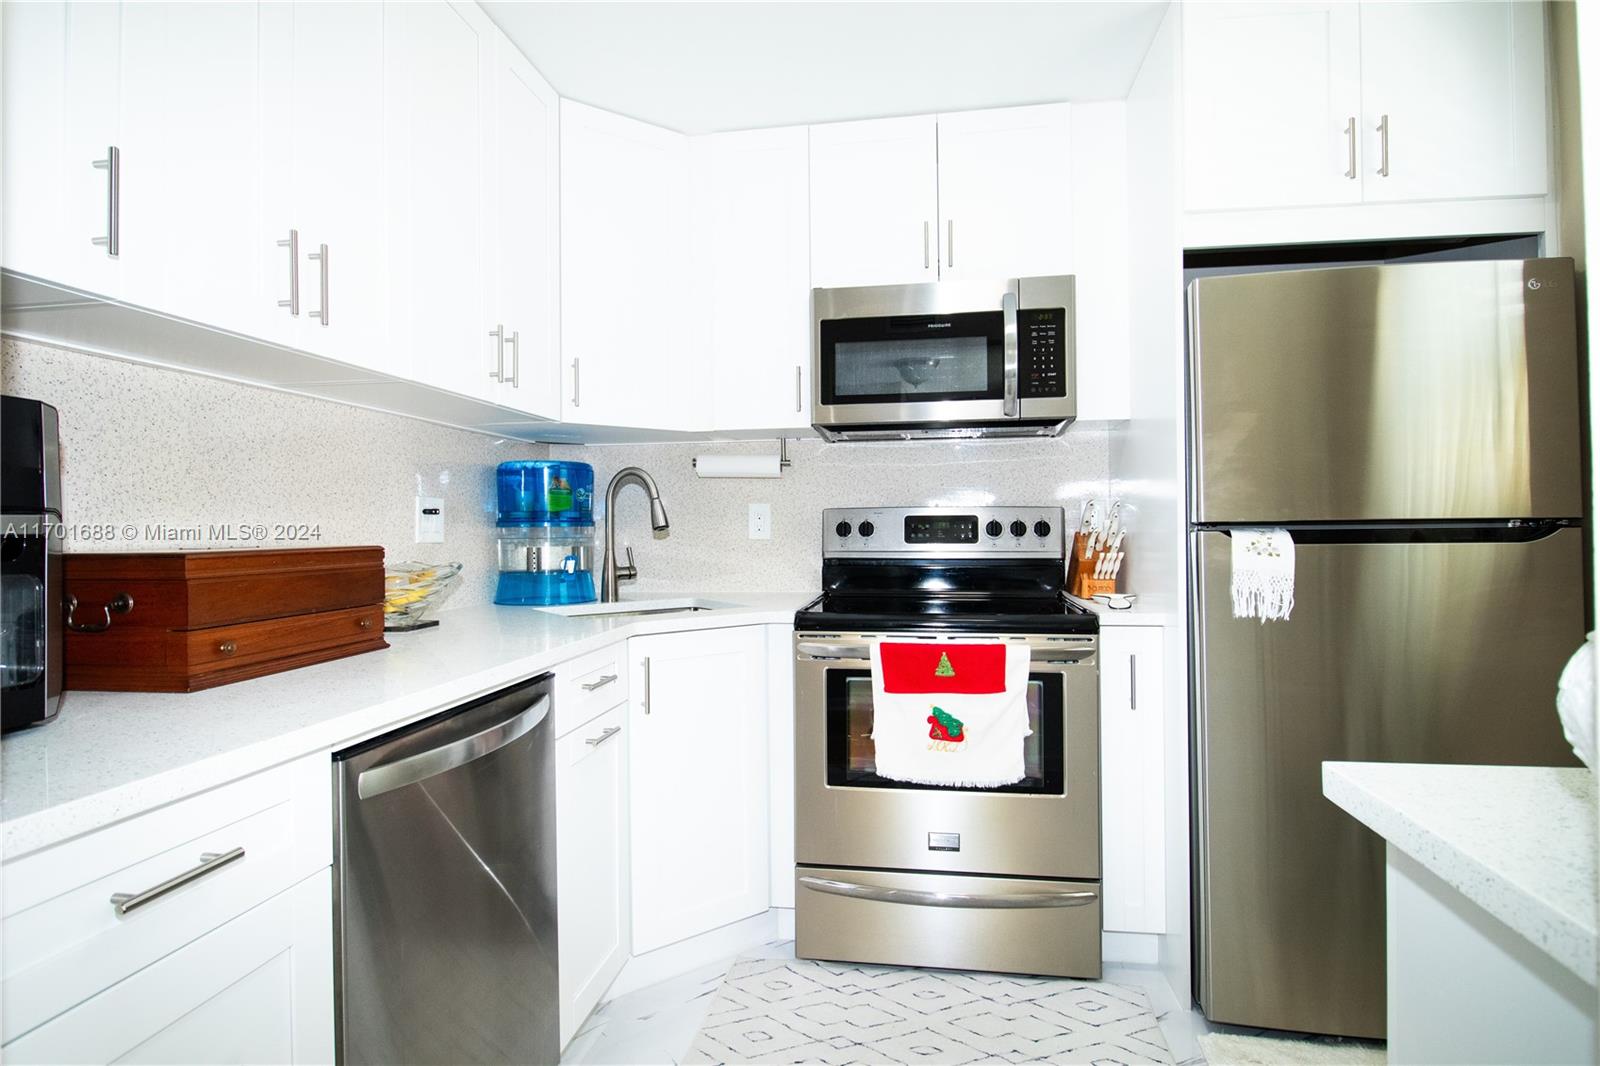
(627, 626, 770, 956)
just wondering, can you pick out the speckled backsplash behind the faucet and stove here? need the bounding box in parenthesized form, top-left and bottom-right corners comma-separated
(550, 424, 1110, 595)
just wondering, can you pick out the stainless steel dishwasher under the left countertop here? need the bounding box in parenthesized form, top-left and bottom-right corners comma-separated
(334, 674, 560, 1063)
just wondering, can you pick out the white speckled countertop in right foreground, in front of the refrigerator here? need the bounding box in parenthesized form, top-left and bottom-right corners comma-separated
(1322, 762, 1597, 984)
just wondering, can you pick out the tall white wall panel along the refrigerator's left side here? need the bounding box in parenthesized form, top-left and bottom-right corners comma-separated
(1109, 5, 1190, 1005)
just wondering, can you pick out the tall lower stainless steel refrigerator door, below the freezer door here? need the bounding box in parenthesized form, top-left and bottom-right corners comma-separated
(1190, 528, 1584, 1037)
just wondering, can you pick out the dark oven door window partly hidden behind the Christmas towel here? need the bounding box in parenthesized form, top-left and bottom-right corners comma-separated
(827, 669, 1066, 795)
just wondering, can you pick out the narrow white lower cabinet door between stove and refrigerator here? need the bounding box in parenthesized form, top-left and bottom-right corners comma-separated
(1101, 626, 1166, 933)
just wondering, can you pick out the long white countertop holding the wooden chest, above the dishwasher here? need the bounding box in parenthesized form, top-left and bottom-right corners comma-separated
(0, 592, 814, 860)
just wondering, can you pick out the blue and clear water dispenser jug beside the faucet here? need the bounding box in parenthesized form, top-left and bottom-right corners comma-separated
(494, 459, 595, 607)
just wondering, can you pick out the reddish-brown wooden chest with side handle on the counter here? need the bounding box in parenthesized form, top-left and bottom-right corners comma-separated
(66, 547, 389, 691)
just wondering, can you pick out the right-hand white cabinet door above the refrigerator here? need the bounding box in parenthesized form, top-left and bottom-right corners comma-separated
(1362, 0, 1549, 200)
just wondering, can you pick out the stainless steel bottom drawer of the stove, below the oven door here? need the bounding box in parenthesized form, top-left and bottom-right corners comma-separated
(795, 866, 1101, 978)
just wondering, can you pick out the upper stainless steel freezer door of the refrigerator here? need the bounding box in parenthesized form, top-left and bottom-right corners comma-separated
(1189, 259, 1584, 525)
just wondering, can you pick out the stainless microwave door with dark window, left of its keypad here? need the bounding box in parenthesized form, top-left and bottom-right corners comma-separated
(813, 282, 1021, 426)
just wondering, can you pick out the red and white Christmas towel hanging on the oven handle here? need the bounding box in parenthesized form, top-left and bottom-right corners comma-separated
(872, 640, 1032, 787)
